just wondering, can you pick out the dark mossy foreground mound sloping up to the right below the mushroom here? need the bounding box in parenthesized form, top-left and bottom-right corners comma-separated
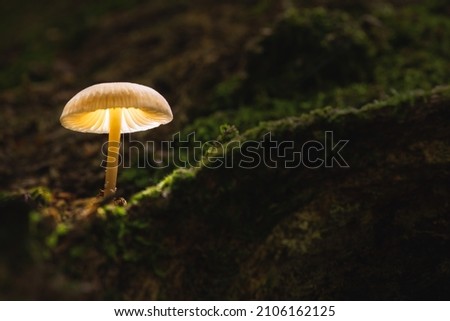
(7, 87, 450, 300)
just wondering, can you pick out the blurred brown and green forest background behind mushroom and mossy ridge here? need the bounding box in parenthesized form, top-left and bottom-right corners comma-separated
(0, 0, 450, 196)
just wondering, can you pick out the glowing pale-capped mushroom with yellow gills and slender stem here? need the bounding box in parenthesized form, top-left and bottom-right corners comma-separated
(60, 82, 173, 198)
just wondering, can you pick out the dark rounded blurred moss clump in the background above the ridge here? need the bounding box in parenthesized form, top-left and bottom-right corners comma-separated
(230, 8, 377, 102)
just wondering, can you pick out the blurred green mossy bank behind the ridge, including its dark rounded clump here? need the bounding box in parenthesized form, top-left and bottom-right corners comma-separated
(186, 3, 450, 141)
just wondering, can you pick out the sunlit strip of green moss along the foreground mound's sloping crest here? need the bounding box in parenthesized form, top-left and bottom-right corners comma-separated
(131, 87, 450, 214)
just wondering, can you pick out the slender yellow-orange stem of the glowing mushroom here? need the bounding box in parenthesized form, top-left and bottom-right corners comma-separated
(104, 108, 122, 197)
